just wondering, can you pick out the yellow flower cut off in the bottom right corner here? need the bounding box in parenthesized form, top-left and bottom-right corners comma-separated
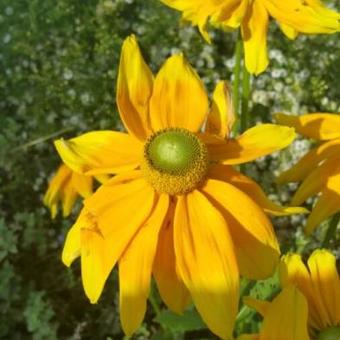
(238, 249, 340, 340)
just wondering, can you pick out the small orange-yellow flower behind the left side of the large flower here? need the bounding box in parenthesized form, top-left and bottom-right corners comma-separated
(44, 164, 92, 218)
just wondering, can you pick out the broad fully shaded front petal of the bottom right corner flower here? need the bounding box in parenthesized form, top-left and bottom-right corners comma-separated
(260, 286, 310, 340)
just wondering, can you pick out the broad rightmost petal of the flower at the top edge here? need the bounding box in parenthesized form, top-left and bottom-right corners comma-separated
(263, 0, 340, 34)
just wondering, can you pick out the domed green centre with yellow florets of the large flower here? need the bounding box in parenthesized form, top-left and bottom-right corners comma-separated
(142, 128, 208, 195)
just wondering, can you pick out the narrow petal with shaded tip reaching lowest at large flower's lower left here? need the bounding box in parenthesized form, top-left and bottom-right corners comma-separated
(119, 194, 169, 335)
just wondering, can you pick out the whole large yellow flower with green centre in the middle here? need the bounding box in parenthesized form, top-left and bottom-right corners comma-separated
(55, 36, 301, 339)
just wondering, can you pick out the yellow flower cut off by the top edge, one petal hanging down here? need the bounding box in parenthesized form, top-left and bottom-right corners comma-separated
(161, 0, 340, 74)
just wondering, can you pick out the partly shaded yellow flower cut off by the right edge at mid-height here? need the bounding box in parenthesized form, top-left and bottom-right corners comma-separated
(276, 113, 340, 234)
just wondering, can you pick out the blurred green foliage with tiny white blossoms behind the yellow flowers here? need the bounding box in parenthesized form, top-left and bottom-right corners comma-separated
(0, 0, 340, 340)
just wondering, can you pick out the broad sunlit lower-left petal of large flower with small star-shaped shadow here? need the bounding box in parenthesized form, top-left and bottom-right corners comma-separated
(81, 179, 154, 303)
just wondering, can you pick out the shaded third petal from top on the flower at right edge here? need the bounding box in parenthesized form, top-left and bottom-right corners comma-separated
(292, 158, 340, 205)
